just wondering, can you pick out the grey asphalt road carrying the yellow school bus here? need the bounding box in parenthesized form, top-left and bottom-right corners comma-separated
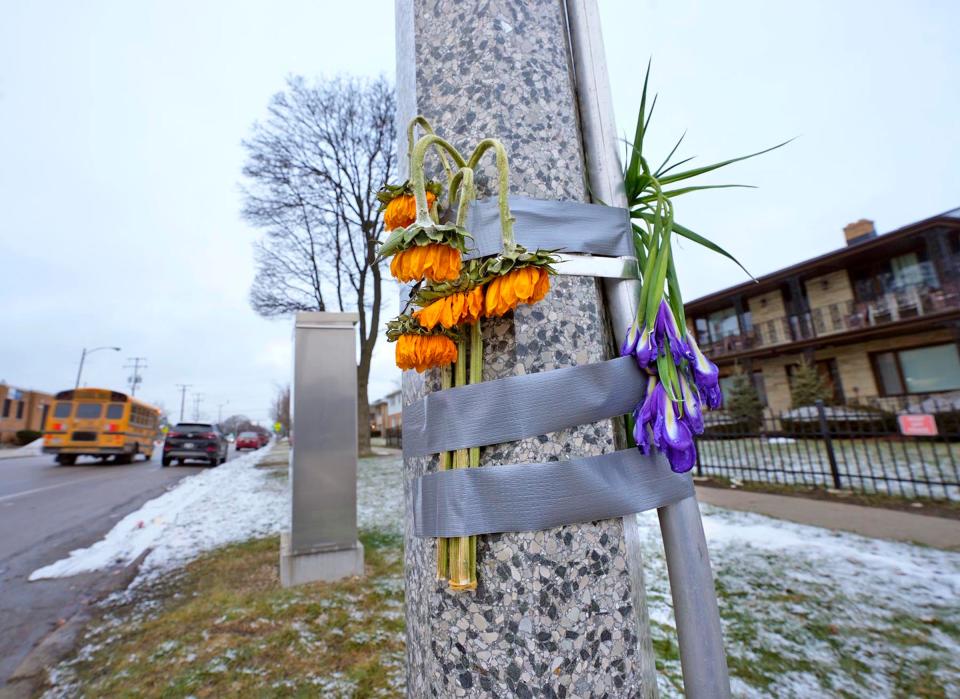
(0, 447, 235, 687)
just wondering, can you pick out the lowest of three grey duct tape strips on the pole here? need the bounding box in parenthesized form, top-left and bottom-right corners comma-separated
(413, 449, 693, 537)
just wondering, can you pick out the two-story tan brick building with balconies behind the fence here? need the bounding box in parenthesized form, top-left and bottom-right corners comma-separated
(685, 209, 960, 412)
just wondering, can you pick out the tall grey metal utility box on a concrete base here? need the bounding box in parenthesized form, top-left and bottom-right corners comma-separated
(280, 313, 363, 586)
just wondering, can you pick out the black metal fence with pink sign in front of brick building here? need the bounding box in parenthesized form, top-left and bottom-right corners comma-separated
(697, 400, 960, 500)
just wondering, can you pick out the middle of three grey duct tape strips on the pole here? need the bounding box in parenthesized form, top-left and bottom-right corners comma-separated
(403, 357, 647, 458)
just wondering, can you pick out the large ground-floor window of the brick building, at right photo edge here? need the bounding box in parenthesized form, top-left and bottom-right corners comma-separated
(873, 342, 960, 396)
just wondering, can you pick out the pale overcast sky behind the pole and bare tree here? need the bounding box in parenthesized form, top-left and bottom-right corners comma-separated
(0, 0, 960, 420)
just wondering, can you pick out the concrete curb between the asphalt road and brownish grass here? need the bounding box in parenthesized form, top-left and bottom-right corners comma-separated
(0, 549, 151, 699)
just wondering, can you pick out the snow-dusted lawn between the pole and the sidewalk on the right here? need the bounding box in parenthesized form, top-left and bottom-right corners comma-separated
(639, 505, 960, 697)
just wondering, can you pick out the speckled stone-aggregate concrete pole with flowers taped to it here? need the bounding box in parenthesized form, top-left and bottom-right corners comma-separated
(397, 0, 656, 697)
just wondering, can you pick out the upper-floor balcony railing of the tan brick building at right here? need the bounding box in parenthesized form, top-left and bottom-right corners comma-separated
(701, 282, 960, 357)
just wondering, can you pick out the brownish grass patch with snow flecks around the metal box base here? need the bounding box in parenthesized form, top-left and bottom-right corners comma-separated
(47, 531, 405, 697)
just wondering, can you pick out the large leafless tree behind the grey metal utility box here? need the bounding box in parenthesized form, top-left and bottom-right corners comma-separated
(243, 77, 396, 453)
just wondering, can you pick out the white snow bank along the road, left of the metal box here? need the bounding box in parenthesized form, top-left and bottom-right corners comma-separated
(30, 445, 289, 581)
